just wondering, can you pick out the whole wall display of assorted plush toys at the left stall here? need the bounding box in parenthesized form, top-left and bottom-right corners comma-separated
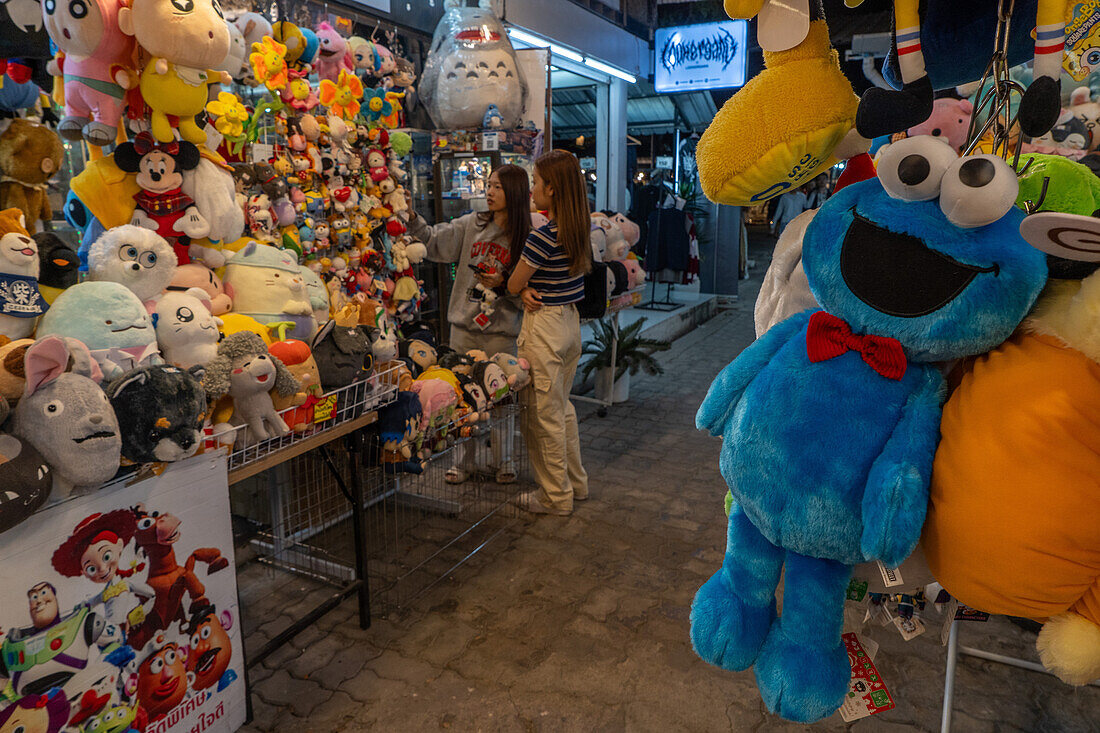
(0, 0, 550, 541)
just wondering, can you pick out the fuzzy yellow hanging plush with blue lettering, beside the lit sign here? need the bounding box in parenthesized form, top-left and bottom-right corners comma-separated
(695, 16, 869, 206)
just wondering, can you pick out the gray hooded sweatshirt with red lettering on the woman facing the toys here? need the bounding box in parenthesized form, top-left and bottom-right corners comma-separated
(408, 214, 524, 340)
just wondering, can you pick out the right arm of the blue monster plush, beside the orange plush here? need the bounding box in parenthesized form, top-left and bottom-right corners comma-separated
(860, 364, 945, 568)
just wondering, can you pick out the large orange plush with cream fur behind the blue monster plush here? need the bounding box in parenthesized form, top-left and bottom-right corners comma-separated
(923, 272, 1100, 685)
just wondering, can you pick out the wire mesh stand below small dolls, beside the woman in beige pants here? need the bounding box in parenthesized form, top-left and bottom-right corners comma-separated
(364, 403, 534, 613)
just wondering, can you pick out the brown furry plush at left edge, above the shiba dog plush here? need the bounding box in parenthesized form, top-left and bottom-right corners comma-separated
(0, 118, 65, 231)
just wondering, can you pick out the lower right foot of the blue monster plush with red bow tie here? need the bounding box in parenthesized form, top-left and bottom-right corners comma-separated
(756, 624, 851, 723)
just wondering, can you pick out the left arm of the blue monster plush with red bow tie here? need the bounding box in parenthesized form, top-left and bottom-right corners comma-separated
(695, 310, 814, 436)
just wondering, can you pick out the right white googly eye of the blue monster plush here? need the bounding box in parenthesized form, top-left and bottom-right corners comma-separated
(939, 155, 1020, 229)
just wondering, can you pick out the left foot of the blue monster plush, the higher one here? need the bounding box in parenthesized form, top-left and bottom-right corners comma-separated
(691, 570, 776, 671)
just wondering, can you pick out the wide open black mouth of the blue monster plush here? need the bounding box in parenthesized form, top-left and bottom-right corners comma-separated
(840, 208, 1000, 318)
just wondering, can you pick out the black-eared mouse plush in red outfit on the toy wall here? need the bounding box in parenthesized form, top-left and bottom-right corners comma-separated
(114, 132, 210, 264)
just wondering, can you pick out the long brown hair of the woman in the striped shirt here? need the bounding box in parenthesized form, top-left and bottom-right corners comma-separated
(535, 150, 592, 275)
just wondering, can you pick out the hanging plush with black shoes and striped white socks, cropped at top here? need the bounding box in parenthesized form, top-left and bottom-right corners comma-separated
(846, 0, 1069, 138)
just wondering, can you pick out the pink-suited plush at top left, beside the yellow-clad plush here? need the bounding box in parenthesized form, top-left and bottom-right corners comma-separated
(42, 0, 136, 145)
